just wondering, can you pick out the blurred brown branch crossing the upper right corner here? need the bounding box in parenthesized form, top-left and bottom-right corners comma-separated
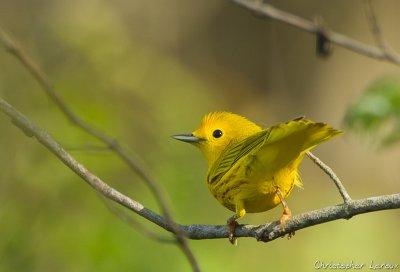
(232, 0, 400, 65)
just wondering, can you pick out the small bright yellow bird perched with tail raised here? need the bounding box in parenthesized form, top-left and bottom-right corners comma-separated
(172, 111, 342, 244)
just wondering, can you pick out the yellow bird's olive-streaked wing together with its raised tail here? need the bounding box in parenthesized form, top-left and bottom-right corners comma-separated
(207, 118, 341, 183)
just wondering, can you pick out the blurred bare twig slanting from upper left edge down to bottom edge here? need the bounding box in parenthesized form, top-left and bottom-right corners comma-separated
(0, 26, 200, 271)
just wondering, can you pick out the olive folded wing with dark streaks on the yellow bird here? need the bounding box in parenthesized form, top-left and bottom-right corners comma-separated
(207, 130, 270, 183)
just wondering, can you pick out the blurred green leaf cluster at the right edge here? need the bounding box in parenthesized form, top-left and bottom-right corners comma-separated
(344, 76, 400, 146)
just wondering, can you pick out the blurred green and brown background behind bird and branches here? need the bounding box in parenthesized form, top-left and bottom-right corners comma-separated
(0, 0, 400, 271)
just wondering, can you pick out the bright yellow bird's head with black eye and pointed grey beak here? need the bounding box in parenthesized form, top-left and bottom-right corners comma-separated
(172, 112, 261, 167)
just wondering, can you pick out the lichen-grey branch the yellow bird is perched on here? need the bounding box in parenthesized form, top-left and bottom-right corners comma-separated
(0, 95, 400, 242)
